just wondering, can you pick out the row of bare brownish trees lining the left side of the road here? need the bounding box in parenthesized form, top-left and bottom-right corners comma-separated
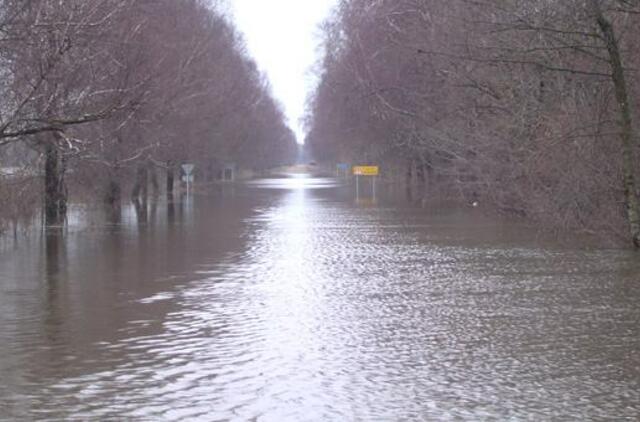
(0, 0, 296, 231)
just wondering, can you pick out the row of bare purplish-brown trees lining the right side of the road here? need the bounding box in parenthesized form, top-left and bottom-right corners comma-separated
(308, 0, 640, 247)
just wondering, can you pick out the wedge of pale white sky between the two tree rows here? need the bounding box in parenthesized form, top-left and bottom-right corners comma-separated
(231, 0, 336, 143)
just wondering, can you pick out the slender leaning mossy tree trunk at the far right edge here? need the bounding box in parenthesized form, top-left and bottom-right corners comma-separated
(594, 9, 640, 248)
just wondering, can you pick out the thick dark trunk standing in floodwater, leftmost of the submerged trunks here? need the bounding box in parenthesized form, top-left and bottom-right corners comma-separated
(44, 142, 67, 226)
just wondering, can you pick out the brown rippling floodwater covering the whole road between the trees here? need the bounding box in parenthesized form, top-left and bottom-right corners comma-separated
(0, 177, 640, 421)
